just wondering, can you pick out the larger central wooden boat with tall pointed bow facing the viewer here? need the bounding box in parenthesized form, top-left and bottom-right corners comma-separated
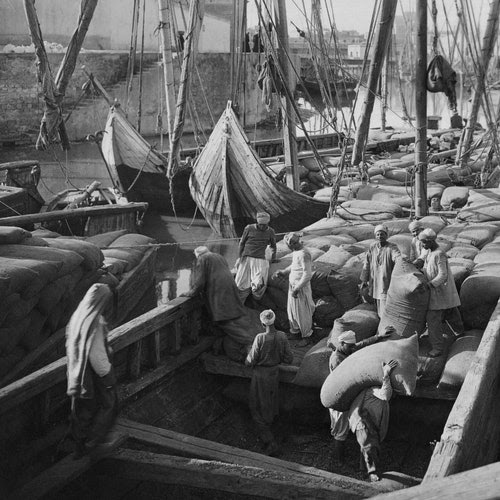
(189, 102, 328, 238)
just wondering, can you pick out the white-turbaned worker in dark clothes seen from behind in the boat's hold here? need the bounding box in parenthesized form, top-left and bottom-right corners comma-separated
(245, 309, 293, 455)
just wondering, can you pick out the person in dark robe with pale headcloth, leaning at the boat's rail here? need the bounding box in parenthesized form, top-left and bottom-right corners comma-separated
(181, 246, 245, 322)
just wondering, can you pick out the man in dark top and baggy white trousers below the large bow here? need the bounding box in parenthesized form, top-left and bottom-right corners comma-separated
(235, 212, 276, 302)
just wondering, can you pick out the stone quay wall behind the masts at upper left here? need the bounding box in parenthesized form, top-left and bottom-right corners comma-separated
(0, 51, 267, 142)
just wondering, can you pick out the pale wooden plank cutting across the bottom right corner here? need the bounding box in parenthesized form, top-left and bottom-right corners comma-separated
(373, 462, 500, 500)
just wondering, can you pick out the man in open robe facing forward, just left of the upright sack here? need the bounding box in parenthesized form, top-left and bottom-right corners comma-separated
(360, 224, 401, 317)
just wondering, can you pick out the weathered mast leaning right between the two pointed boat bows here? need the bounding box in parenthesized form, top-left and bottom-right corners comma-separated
(167, 0, 205, 179)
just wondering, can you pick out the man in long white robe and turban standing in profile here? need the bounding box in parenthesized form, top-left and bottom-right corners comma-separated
(275, 233, 314, 347)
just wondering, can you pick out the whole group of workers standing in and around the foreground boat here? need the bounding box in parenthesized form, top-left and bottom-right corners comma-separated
(66, 212, 461, 480)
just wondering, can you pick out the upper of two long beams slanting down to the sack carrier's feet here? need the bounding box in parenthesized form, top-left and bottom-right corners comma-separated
(117, 418, 382, 495)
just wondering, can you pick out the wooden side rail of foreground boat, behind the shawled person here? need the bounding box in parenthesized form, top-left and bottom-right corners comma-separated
(0, 298, 205, 442)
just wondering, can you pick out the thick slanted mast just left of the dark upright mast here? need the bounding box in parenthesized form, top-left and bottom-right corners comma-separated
(352, 0, 398, 167)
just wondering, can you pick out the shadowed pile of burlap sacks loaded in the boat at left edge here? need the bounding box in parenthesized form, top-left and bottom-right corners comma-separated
(0, 226, 153, 377)
